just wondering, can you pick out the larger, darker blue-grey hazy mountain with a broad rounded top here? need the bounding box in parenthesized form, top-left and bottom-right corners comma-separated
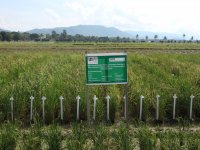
(27, 25, 132, 37)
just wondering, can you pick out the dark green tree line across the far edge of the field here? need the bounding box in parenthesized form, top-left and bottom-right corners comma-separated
(0, 30, 200, 43)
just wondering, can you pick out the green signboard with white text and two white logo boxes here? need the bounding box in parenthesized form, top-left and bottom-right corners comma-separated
(86, 53, 127, 85)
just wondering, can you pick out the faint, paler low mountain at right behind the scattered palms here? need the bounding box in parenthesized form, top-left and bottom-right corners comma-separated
(126, 31, 183, 39)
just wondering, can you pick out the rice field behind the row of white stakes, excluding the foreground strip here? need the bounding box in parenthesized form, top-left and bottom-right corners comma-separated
(0, 42, 200, 124)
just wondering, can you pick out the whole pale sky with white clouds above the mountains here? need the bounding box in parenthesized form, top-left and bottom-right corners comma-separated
(0, 0, 200, 36)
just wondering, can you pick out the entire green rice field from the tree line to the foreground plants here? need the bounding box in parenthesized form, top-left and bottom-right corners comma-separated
(0, 42, 200, 150)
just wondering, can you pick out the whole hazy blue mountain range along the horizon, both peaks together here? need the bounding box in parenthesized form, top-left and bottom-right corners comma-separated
(0, 25, 182, 39)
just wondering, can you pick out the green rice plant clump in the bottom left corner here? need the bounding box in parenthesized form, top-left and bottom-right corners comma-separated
(0, 122, 19, 150)
